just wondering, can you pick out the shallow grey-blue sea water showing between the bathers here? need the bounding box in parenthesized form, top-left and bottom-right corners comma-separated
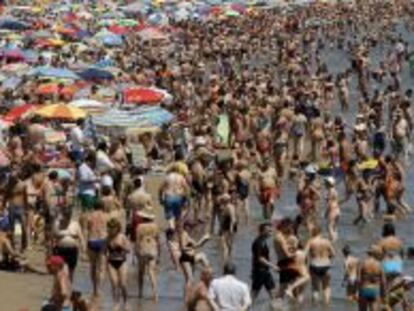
(69, 15, 414, 311)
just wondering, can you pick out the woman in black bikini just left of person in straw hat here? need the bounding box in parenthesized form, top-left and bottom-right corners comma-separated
(106, 218, 130, 311)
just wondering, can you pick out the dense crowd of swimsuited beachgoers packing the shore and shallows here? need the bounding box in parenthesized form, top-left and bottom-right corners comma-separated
(0, 0, 414, 311)
